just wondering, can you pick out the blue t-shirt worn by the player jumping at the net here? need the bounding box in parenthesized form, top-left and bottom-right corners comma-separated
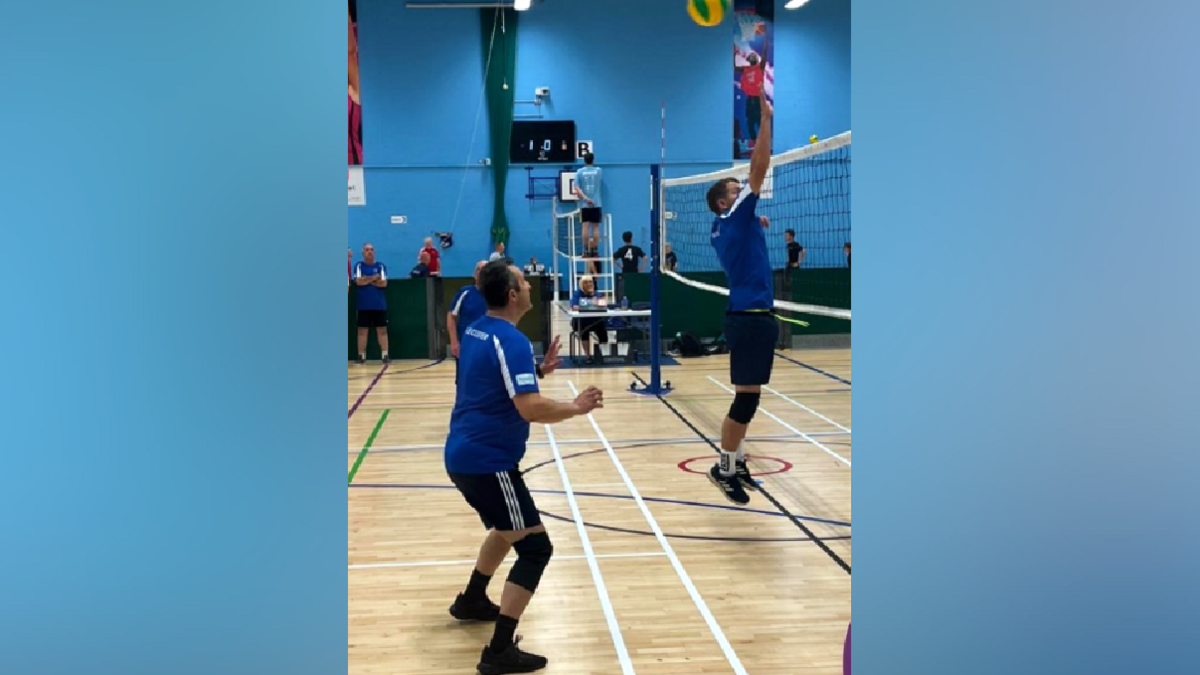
(713, 184, 775, 311)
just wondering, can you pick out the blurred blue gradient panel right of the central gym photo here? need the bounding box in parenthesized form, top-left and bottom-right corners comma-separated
(852, 0, 1200, 675)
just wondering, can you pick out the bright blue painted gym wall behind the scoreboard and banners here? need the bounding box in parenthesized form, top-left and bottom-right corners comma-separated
(349, 0, 851, 276)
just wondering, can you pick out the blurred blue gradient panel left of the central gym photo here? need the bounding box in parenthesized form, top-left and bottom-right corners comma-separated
(0, 0, 347, 675)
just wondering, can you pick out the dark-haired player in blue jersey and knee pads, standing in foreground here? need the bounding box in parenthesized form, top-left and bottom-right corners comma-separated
(445, 259, 604, 675)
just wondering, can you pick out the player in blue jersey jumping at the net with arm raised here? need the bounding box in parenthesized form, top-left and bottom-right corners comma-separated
(708, 97, 779, 504)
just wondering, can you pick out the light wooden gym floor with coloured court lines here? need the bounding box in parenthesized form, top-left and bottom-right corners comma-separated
(347, 312, 852, 675)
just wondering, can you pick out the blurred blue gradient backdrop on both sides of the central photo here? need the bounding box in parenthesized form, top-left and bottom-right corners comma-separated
(0, 0, 1200, 675)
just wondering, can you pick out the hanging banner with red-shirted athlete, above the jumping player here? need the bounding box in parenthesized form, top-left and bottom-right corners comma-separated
(733, 0, 775, 160)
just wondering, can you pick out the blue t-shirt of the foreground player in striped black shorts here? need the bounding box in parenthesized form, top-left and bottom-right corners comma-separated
(445, 315, 538, 473)
